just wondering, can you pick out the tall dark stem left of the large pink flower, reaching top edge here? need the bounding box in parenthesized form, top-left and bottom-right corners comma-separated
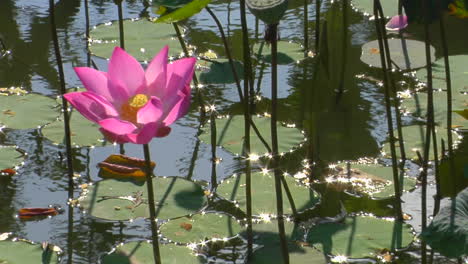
(49, 0, 74, 199)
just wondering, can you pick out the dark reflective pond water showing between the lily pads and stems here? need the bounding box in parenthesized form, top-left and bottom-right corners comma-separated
(0, 0, 468, 263)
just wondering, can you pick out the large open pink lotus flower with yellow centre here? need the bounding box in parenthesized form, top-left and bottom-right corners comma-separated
(64, 46, 196, 144)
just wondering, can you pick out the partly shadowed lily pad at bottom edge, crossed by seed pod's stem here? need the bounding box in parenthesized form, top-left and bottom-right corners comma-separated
(248, 220, 327, 264)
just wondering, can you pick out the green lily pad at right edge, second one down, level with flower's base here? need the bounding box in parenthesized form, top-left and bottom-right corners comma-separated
(401, 92, 468, 129)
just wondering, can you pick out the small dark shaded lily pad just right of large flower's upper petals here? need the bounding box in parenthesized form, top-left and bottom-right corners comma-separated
(195, 59, 244, 84)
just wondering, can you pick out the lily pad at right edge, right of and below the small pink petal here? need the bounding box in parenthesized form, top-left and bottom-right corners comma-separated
(416, 55, 468, 94)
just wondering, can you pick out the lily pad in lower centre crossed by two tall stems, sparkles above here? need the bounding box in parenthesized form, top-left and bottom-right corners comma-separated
(216, 172, 320, 215)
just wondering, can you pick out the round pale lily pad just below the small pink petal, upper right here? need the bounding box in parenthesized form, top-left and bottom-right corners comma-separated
(361, 38, 435, 70)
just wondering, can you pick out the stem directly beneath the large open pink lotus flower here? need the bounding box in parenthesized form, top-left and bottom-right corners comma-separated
(143, 144, 161, 264)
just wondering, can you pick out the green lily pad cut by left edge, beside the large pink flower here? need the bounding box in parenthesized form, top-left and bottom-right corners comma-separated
(0, 93, 60, 129)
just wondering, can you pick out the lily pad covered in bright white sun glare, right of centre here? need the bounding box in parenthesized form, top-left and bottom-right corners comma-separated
(327, 164, 416, 198)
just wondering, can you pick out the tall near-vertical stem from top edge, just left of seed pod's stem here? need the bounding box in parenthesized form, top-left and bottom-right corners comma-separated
(239, 0, 253, 259)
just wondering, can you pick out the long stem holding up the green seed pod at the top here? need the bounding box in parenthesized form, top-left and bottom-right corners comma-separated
(268, 24, 289, 264)
